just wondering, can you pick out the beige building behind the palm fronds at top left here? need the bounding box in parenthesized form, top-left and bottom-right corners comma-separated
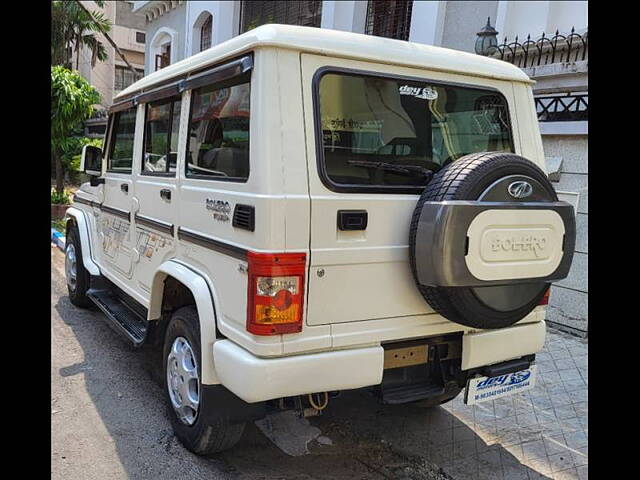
(71, 1, 146, 137)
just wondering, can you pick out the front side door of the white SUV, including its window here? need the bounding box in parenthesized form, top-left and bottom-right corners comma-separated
(96, 106, 138, 281)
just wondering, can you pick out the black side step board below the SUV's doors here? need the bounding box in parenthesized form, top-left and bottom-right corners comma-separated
(87, 288, 148, 347)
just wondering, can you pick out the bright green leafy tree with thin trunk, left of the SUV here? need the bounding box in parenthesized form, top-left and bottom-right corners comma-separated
(51, 65, 100, 195)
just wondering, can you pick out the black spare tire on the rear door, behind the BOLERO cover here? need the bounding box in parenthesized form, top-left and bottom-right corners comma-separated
(409, 152, 575, 329)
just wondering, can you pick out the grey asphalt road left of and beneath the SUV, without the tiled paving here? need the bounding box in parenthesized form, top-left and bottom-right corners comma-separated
(51, 247, 449, 480)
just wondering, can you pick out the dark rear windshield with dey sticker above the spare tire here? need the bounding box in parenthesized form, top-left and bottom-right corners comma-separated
(318, 73, 513, 190)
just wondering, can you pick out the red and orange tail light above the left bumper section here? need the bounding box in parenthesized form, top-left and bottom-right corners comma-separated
(247, 252, 307, 335)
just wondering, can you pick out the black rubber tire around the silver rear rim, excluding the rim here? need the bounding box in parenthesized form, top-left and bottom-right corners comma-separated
(162, 306, 245, 455)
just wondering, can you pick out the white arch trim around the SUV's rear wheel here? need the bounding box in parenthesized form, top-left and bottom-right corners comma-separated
(148, 260, 220, 385)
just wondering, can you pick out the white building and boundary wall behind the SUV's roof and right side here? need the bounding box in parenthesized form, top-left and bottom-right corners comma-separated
(133, 0, 588, 336)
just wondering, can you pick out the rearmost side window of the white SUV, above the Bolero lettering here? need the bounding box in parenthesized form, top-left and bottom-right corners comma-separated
(186, 83, 250, 182)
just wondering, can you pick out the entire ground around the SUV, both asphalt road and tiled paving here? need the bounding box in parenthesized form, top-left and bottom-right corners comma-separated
(51, 248, 588, 480)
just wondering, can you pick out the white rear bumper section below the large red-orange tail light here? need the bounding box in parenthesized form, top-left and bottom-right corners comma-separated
(213, 340, 384, 403)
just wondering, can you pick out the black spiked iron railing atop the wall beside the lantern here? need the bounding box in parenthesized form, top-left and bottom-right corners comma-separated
(489, 28, 589, 68)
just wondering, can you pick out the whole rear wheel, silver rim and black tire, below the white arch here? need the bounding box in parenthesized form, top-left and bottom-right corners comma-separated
(163, 306, 245, 455)
